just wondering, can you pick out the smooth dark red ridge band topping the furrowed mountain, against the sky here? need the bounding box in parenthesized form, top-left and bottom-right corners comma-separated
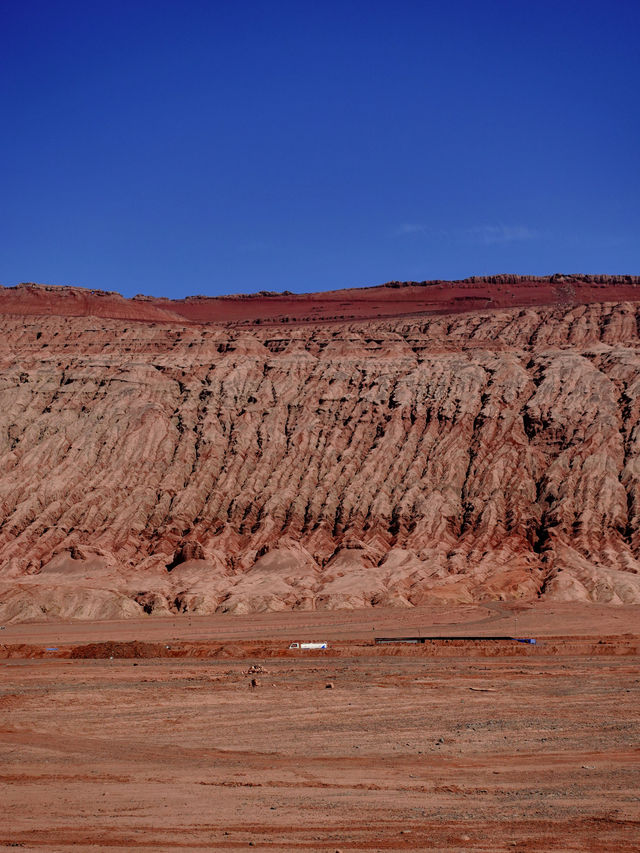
(0, 274, 640, 324)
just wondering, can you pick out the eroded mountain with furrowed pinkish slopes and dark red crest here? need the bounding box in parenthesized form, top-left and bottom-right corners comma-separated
(0, 276, 640, 623)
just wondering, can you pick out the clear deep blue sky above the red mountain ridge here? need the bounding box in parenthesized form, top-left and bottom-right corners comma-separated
(0, 0, 640, 297)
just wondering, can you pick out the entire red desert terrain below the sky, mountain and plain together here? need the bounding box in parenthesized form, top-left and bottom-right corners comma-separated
(0, 275, 640, 853)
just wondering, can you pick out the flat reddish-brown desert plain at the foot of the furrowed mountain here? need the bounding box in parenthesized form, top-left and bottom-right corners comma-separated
(0, 605, 640, 853)
